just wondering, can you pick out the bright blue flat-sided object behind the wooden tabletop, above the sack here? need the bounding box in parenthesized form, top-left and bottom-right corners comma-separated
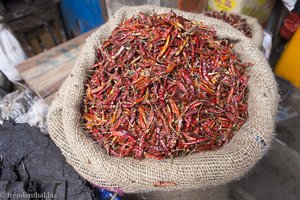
(60, 0, 105, 36)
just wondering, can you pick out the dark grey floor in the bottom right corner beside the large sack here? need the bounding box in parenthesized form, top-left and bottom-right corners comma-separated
(232, 138, 300, 200)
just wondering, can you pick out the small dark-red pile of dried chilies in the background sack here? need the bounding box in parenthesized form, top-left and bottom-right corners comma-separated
(205, 11, 252, 38)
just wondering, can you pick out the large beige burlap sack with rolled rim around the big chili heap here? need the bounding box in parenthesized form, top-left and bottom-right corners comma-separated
(48, 6, 278, 195)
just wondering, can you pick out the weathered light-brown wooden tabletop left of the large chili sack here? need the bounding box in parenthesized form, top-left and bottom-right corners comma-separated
(16, 29, 95, 101)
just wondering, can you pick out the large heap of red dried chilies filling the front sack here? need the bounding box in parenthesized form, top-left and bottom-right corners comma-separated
(82, 12, 250, 160)
